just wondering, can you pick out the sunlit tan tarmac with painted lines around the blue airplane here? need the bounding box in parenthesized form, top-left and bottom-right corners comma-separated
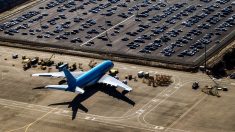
(0, 46, 235, 132)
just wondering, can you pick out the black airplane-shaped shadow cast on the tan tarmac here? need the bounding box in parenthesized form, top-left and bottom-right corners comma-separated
(49, 84, 135, 120)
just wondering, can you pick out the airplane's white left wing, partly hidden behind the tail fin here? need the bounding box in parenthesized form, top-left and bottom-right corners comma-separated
(32, 71, 84, 78)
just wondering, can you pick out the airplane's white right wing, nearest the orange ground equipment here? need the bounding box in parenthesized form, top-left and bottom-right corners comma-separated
(98, 75, 132, 91)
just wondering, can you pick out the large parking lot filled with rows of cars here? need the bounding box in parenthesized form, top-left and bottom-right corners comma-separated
(0, 0, 235, 65)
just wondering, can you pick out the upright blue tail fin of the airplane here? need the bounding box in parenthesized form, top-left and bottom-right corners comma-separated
(63, 68, 76, 92)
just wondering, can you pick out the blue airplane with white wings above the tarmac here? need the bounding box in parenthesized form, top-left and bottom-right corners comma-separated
(32, 60, 132, 94)
